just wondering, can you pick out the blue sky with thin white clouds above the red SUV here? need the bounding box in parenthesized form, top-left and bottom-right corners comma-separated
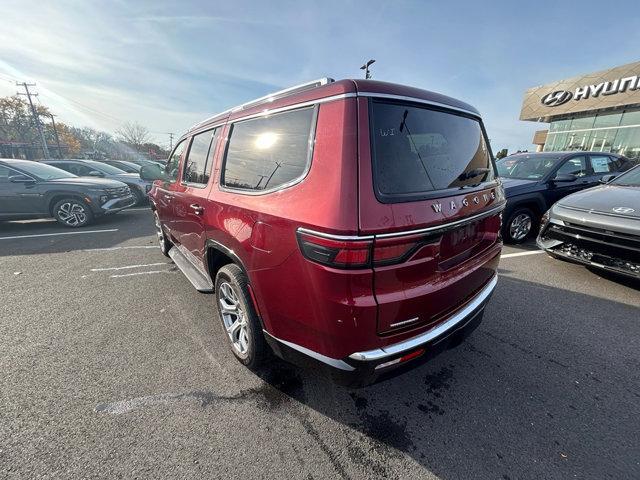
(0, 0, 640, 151)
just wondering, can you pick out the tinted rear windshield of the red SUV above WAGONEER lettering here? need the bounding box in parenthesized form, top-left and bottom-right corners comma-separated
(371, 101, 494, 202)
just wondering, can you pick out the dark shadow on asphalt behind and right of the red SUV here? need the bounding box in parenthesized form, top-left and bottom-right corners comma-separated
(250, 277, 640, 479)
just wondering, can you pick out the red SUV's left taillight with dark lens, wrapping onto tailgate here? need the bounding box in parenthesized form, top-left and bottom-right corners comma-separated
(298, 229, 440, 269)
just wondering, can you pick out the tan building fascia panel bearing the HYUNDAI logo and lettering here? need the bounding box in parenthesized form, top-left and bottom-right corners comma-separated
(520, 62, 640, 122)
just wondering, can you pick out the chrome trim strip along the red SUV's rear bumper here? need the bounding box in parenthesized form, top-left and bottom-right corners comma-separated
(349, 275, 498, 361)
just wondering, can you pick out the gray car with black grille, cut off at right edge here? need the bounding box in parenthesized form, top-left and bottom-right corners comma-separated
(537, 166, 640, 278)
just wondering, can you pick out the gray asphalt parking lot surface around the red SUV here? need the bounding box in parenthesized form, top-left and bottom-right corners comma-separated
(0, 209, 640, 479)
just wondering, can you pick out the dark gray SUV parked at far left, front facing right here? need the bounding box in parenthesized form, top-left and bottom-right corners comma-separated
(0, 159, 135, 227)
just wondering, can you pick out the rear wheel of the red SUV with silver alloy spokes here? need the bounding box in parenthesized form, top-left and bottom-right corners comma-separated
(215, 264, 269, 370)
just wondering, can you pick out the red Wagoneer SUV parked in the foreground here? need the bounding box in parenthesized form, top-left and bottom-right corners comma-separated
(142, 79, 505, 385)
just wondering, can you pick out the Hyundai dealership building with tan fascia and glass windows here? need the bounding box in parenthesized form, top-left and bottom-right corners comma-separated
(520, 62, 640, 158)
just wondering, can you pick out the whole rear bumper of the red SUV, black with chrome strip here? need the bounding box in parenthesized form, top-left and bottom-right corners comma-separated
(265, 276, 497, 387)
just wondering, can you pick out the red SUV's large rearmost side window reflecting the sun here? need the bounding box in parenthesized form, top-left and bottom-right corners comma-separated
(222, 107, 315, 192)
